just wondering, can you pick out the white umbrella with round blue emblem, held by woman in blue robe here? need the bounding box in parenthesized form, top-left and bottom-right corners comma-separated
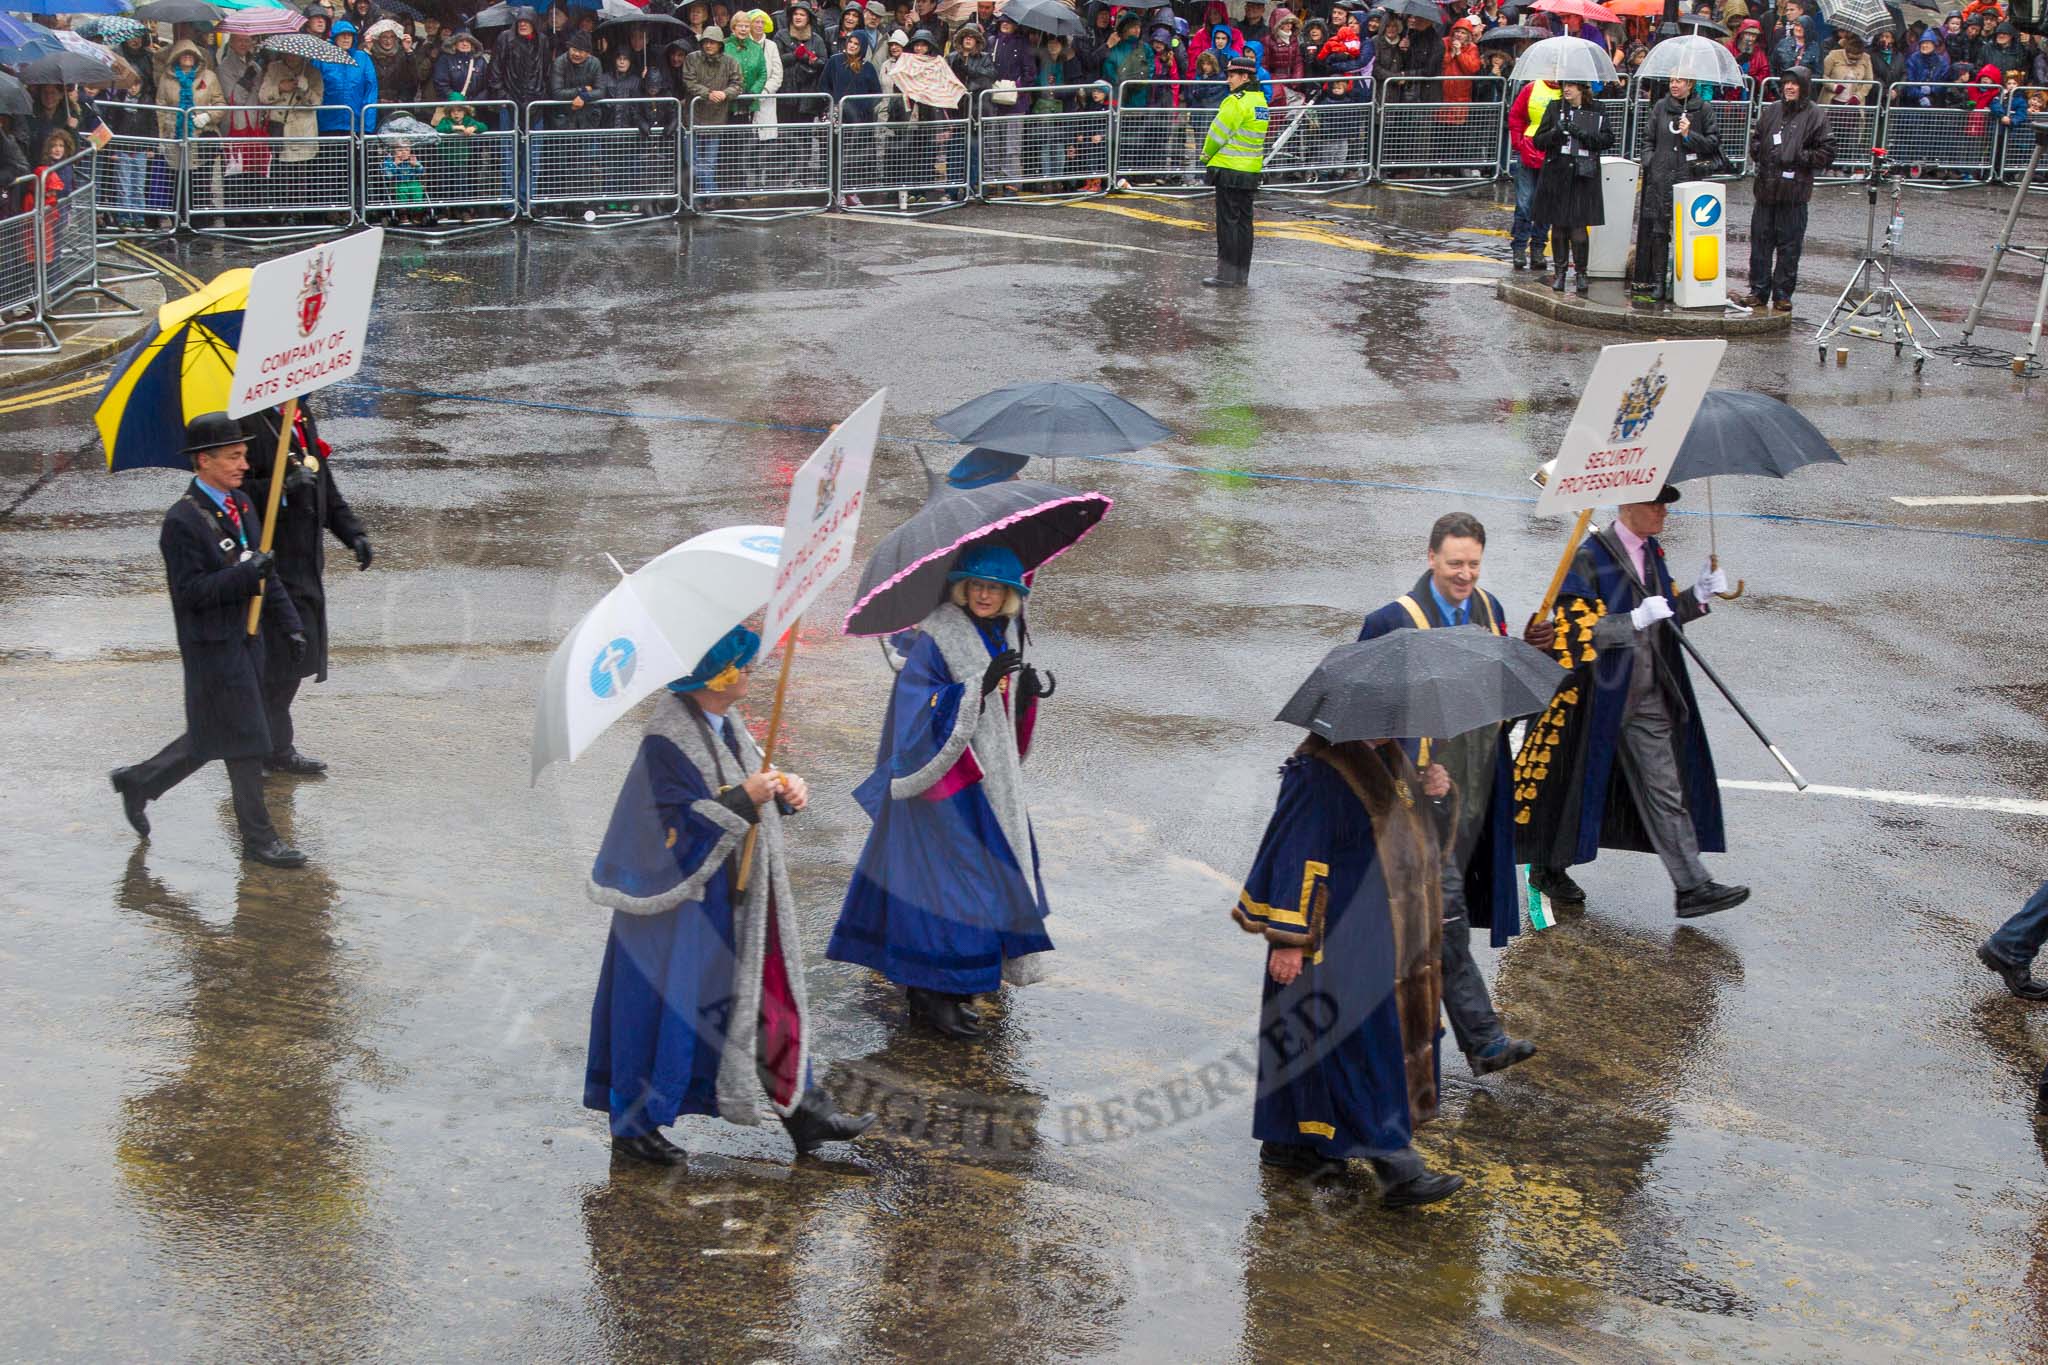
(532, 526, 782, 782)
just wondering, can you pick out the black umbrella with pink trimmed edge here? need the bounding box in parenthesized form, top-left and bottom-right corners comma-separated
(842, 479, 1114, 638)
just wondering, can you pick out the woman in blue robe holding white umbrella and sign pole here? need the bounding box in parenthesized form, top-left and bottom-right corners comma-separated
(584, 626, 874, 1164)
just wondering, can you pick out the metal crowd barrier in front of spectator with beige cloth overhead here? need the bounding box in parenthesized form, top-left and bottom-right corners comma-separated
(838, 94, 979, 217)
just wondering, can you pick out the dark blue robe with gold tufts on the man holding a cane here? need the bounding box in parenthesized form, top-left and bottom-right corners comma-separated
(1513, 532, 1729, 868)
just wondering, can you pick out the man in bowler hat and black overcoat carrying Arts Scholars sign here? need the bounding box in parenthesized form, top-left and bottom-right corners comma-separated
(113, 413, 305, 868)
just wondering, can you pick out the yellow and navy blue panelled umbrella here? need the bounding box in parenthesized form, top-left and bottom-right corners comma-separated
(92, 270, 250, 469)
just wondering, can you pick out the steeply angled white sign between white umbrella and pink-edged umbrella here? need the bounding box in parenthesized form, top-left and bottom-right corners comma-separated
(762, 389, 889, 649)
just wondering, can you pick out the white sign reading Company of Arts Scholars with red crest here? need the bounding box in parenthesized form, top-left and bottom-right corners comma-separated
(227, 227, 383, 417)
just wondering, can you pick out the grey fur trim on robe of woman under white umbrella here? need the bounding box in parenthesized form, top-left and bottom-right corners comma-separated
(590, 692, 811, 1126)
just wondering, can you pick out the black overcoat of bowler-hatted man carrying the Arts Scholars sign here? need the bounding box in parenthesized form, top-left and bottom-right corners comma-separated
(158, 479, 299, 759)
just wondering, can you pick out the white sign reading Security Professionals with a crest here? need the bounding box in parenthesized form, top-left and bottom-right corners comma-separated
(1536, 340, 1729, 516)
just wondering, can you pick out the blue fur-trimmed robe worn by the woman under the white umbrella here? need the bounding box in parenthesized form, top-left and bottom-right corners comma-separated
(584, 696, 809, 1138)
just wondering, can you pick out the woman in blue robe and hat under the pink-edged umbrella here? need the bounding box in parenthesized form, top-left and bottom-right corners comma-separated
(825, 542, 1053, 1038)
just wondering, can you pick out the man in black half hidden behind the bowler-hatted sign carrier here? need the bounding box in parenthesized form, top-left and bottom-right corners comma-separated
(244, 401, 371, 776)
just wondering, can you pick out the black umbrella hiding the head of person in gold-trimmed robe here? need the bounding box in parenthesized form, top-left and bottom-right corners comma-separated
(1274, 626, 1565, 745)
